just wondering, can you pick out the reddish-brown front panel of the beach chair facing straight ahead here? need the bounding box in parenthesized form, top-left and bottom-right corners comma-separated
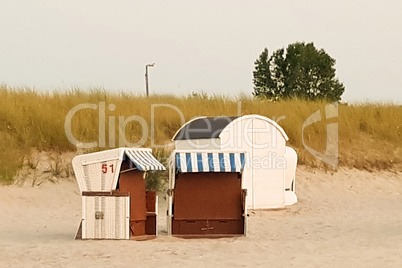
(172, 172, 244, 235)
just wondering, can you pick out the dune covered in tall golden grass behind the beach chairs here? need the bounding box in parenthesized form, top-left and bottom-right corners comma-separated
(0, 86, 402, 183)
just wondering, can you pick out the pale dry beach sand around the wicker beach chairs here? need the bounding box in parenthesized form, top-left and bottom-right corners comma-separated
(0, 167, 402, 267)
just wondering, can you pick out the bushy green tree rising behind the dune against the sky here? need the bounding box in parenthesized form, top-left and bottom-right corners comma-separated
(253, 43, 345, 101)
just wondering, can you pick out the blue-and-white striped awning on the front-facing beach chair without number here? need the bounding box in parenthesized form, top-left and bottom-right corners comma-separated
(175, 152, 245, 173)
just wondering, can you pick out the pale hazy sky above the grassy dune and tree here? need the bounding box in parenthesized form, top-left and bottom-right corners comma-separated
(0, 0, 402, 103)
